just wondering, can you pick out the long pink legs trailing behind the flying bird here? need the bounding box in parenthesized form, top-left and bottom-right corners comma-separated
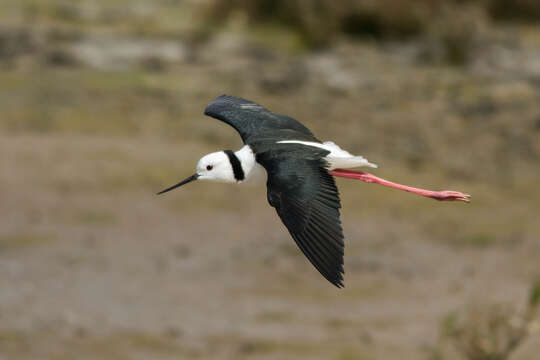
(330, 169, 471, 202)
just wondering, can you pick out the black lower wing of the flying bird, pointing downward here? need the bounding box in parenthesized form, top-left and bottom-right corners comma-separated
(258, 149, 344, 287)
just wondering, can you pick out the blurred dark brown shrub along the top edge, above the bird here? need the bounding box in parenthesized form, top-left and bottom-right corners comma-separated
(202, 0, 440, 47)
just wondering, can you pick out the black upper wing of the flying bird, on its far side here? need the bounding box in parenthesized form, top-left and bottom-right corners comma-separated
(204, 95, 318, 143)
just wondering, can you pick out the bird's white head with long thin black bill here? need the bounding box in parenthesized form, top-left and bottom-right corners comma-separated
(158, 151, 236, 195)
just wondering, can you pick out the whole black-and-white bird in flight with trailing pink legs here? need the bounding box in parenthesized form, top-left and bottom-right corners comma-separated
(158, 95, 470, 287)
